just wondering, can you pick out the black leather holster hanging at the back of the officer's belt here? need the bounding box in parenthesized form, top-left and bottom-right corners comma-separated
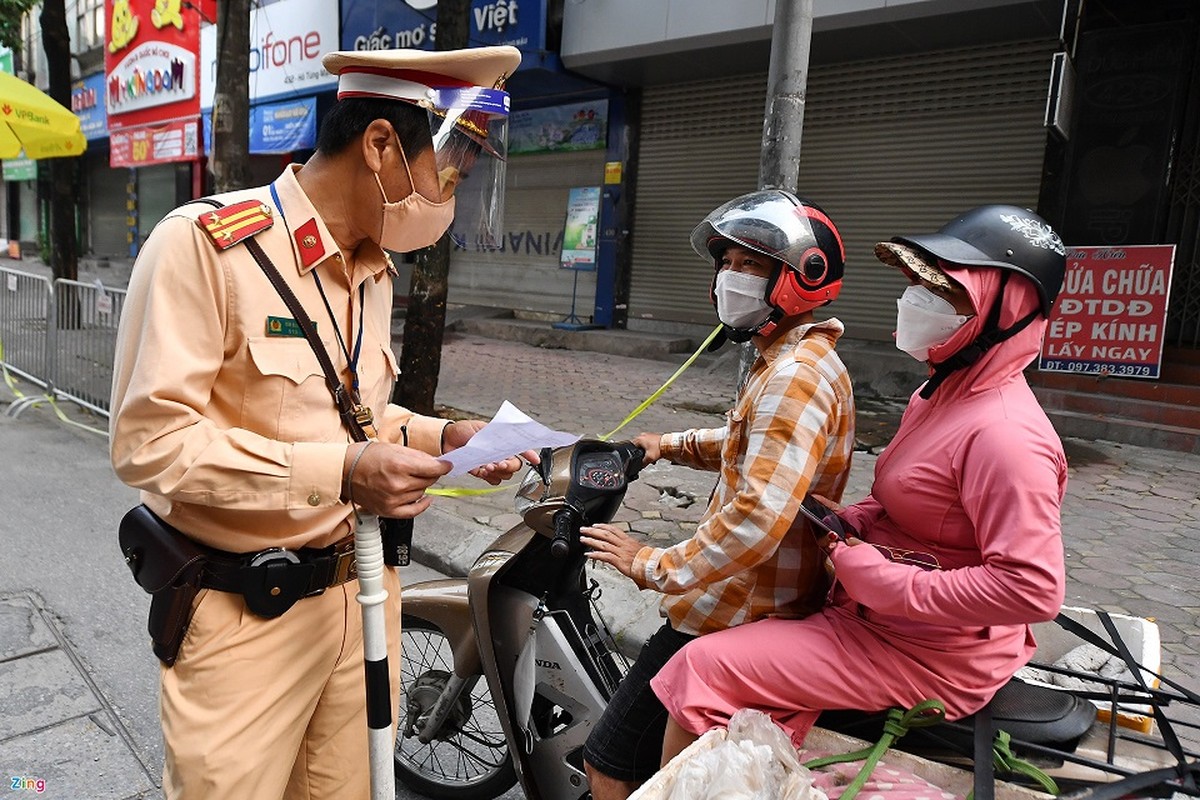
(118, 505, 206, 667)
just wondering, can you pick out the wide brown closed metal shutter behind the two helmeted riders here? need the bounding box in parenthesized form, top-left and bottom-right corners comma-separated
(630, 41, 1055, 339)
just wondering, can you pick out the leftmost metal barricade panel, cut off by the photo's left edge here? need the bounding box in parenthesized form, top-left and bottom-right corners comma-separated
(0, 267, 55, 389)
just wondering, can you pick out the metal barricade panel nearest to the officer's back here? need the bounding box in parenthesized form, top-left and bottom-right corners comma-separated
(52, 278, 125, 416)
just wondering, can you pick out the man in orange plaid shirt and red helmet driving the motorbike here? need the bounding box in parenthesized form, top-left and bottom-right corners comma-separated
(582, 190, 854, 800)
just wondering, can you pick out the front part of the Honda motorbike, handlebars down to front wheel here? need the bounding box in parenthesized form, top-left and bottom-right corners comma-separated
(395, 439, 646, 800)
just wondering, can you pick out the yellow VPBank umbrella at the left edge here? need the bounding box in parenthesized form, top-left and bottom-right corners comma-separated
(0, 72, 88, 160)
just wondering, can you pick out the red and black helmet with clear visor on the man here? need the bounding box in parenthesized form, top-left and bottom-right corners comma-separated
(691, 188, 846, 335)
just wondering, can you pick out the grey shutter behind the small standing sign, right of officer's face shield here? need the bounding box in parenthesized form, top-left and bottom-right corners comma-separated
(448, 150, 605, 317)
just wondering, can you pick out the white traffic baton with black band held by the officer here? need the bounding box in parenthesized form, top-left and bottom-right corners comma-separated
(354, 515, 396, 800)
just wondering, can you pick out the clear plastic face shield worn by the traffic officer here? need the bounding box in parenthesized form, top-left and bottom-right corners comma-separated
(430, 86, 509, 249)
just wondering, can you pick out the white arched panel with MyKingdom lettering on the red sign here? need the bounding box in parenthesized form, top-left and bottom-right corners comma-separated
(107, 42, 198, 114)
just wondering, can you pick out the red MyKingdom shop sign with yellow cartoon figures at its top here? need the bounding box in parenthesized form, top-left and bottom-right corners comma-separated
(104, 0, 200, 131)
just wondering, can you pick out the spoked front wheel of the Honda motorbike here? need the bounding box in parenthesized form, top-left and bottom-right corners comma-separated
(394, 614, 517, 800)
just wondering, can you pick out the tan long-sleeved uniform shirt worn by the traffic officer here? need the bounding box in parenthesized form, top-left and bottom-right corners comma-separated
(110, 166, 446, 553)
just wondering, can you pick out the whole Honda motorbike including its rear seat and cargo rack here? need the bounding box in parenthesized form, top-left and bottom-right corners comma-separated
(395, 439, 1200, 800)
